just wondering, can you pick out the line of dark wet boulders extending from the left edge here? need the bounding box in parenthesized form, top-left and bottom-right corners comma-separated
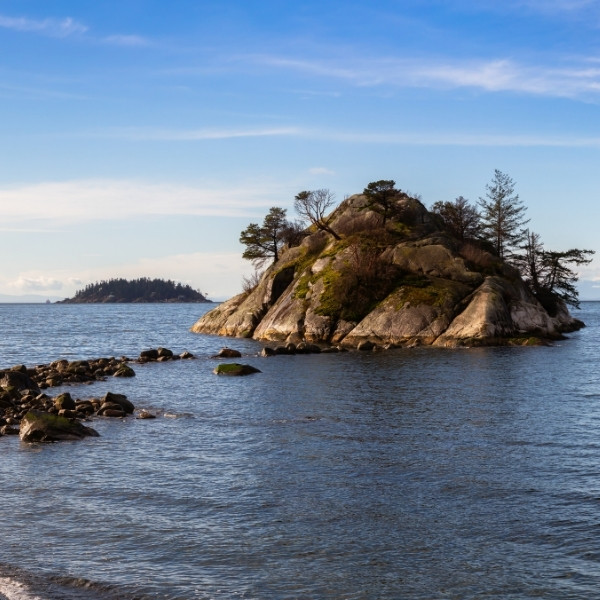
(0, 347, 195, 442)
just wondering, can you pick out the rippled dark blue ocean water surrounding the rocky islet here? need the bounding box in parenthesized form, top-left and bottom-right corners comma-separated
(0, 303, 600, 600)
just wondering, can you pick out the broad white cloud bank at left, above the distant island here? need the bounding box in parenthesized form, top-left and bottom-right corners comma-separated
(0, 180, 289, 230)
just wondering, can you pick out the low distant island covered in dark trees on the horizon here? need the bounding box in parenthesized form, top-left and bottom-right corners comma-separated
(59, 277, 210, 304)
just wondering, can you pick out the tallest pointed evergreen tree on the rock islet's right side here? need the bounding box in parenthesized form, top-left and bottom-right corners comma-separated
(479, 169, 529, 259)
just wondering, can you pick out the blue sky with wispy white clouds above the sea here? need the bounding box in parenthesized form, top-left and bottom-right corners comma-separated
(0, 0, 600, 299)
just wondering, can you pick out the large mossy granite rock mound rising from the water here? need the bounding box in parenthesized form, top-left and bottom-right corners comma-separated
(192, 195, 583, 347)
